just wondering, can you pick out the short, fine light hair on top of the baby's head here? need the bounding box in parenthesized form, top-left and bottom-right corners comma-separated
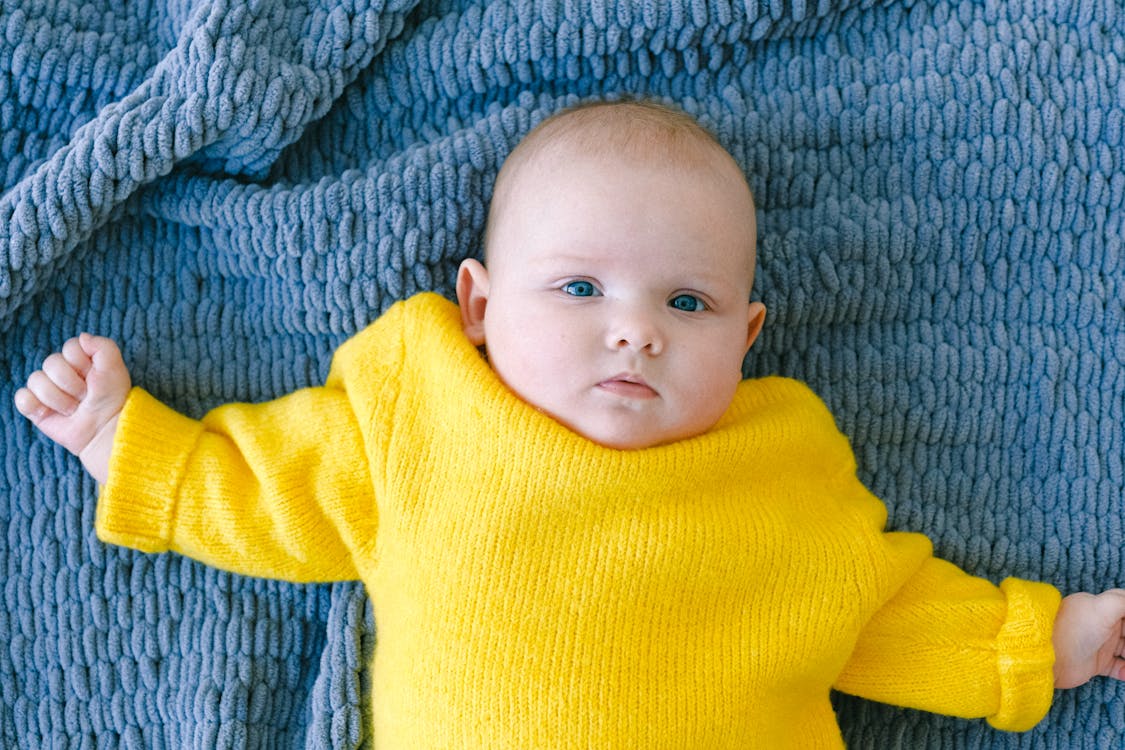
(484, 99, 753, 259)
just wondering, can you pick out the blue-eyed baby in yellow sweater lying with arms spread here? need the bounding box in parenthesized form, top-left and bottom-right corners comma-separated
(16, 102, 1125, 749)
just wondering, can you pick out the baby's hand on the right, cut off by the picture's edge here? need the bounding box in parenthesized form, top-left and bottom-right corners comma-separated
(1052, 589, 1125, 688)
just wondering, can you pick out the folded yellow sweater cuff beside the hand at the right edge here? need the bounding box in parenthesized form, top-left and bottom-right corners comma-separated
(988, 578, 1062, 732)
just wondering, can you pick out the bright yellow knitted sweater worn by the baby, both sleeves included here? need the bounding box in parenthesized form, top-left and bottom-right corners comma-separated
(98, 295, 1059, 750)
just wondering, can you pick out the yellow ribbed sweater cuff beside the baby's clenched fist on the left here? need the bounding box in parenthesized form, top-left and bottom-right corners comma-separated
(96, 388, 203, 552)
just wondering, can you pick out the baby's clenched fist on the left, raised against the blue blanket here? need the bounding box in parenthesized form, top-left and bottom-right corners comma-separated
(16, 333, 132, 484)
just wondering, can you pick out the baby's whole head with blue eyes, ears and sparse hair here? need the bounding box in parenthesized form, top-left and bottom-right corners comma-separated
(457, 102, 765, 449)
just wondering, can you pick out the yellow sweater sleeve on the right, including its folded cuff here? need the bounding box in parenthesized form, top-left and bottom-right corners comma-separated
(836, 533, 1061, 731)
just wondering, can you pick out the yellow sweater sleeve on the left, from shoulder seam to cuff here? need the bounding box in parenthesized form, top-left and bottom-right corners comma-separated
(96, 296, 406, 582)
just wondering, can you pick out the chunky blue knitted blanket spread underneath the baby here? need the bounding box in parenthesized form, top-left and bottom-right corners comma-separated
(0, 0, 1125, 750)
